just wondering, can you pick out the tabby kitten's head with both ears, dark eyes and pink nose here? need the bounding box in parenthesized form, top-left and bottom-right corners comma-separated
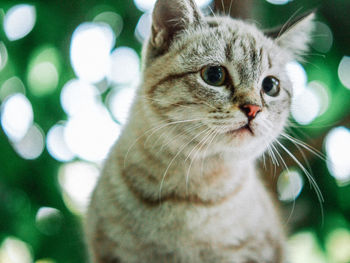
(143, 0, 314, 161)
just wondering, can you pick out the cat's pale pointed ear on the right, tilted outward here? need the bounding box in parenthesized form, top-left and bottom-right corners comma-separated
(265, 10, 315, 59)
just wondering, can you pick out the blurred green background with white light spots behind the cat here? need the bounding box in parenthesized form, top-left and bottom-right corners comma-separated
(0, 0, 350, 263)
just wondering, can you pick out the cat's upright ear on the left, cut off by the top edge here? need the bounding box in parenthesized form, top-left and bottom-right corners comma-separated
(151, 0, 203, 49)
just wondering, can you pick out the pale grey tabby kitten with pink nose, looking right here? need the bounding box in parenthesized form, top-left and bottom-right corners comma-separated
(85, 0, 315, 263)
